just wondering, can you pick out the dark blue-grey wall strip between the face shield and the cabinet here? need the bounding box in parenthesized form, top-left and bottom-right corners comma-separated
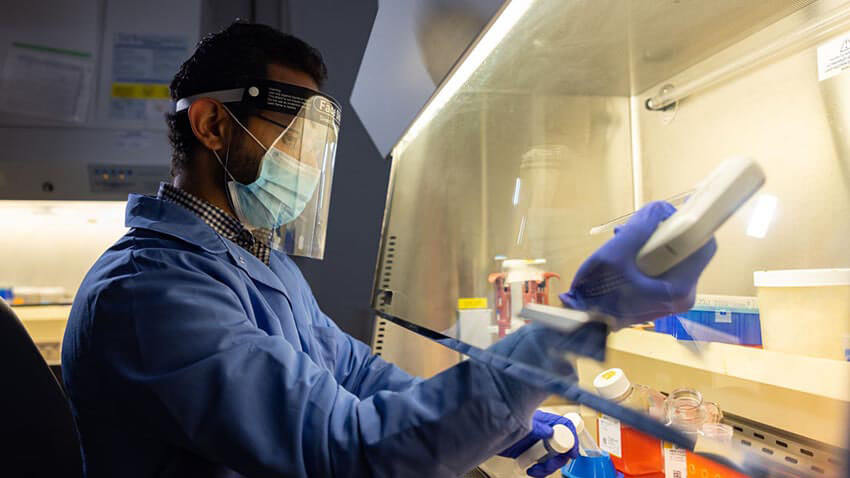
(288, 0, 390, 343)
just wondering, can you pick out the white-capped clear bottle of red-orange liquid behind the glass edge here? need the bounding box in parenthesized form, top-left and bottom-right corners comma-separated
(593, 368, 664, 478)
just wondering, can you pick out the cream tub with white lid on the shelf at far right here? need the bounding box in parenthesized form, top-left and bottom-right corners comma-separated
(753, 269, 850, 360)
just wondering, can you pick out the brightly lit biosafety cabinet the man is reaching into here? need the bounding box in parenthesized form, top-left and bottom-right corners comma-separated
(373, 0, 850, 476)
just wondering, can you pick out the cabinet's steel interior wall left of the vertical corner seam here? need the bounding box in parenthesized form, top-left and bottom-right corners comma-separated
(377, 94, 632, 375)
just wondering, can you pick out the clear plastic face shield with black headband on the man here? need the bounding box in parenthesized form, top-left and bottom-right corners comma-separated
(176, 80, 340, 259)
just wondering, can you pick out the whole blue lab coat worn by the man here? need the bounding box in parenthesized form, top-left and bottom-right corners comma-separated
(62, 195, 541, 478)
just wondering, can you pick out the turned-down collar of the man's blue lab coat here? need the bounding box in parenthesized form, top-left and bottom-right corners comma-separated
(124, 194, 289, 299)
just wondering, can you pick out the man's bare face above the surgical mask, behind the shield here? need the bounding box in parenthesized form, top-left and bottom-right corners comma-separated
(227, 64, 319, 184)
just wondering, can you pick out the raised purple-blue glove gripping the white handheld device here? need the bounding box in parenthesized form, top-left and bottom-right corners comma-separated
(561, 202, 717, 327)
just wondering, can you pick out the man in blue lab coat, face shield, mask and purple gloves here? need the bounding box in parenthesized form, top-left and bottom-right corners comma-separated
(62, 24, 714, 477)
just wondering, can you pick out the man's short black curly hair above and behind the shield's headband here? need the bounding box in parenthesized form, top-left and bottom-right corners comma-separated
(165, 22, 328, 176)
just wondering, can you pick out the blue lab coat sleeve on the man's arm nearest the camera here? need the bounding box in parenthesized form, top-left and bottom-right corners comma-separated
(96, 259, 532, 477)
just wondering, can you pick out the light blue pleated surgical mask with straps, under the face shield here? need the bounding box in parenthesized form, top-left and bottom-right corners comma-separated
(216, 107, 321, 229)
